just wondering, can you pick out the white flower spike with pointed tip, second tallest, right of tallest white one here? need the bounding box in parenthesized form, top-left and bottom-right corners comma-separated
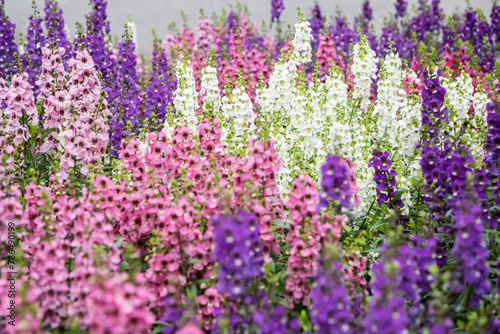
(351, 35, 377, 111)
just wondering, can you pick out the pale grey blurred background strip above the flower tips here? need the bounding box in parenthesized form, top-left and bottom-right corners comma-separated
(5, 0, 492, 53)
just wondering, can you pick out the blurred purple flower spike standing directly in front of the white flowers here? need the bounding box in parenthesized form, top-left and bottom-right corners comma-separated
(318, 155, 352, 210)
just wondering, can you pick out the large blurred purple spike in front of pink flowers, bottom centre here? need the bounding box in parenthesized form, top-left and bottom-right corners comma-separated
(211, 211, 264, 299)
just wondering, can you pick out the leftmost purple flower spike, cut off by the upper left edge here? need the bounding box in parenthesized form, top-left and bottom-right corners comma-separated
(0, 2, 18, 80)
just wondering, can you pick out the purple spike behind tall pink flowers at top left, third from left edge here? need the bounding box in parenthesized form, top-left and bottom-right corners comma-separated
(45, 0, 73, 67)
